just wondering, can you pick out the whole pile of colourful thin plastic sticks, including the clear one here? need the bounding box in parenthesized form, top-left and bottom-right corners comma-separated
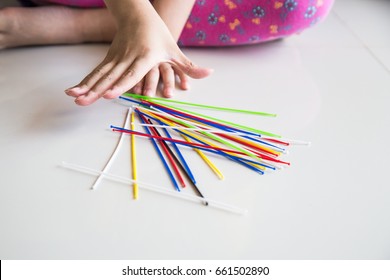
(62, 93, 309, 214)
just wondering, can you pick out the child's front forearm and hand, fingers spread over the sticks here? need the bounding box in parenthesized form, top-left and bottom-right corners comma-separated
(66, 0, 210, 105)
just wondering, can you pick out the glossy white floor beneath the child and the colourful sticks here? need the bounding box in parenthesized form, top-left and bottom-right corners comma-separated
(0, 0, 390, 259)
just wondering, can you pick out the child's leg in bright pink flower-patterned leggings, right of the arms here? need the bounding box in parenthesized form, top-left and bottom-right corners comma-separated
(179, 0, 334, 46)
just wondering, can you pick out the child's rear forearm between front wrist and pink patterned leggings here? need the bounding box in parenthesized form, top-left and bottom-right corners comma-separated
(153, 0, 195, 41)
